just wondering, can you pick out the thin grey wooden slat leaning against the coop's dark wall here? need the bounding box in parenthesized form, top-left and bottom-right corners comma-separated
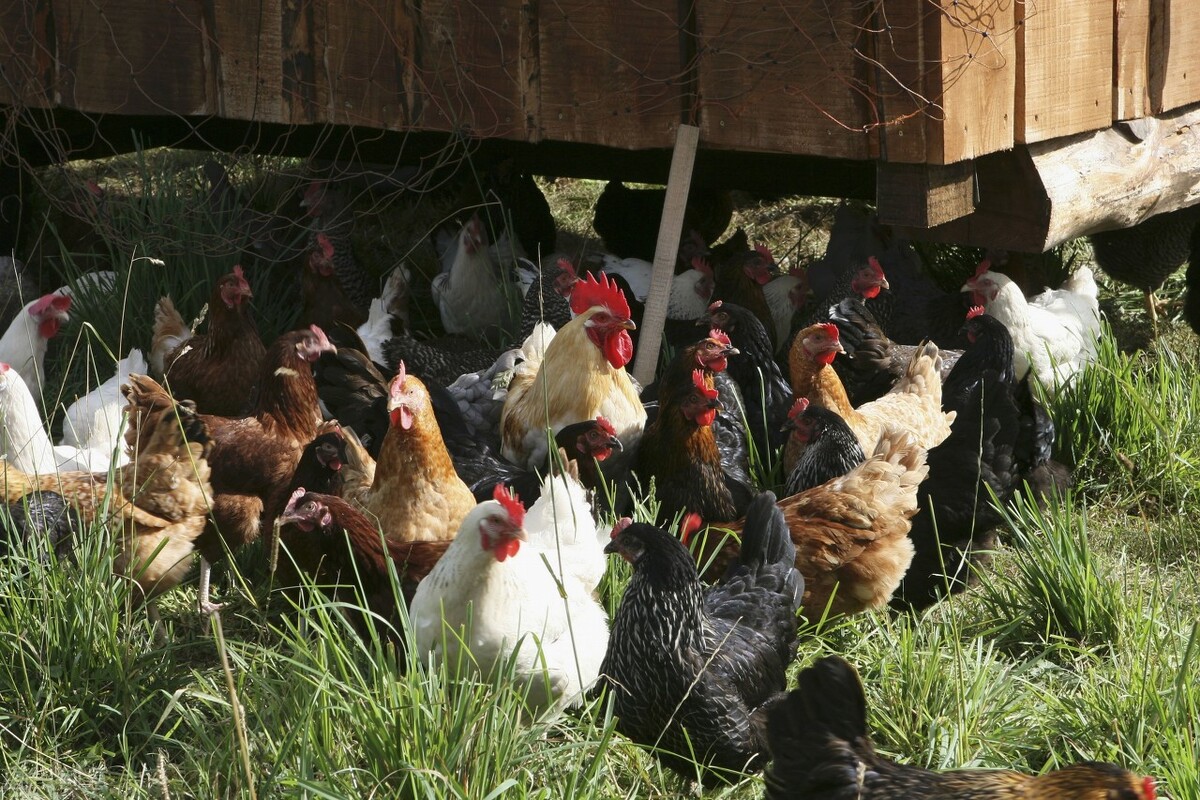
(634, 125, 700, 386)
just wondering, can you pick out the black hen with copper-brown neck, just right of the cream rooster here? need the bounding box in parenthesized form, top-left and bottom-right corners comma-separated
(635, 369, 752, 523)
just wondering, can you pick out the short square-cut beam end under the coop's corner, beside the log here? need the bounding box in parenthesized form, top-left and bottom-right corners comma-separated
(875, 161, 976, 228)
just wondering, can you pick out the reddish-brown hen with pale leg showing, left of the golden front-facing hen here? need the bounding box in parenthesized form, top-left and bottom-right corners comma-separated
(126, 326, 334, 613)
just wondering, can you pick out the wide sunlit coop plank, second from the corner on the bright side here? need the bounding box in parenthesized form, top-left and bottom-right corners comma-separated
(1015, 0, 1114, 143)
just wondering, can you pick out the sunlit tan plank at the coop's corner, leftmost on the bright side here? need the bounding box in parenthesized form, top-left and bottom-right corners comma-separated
(926, 0, 1017, 164)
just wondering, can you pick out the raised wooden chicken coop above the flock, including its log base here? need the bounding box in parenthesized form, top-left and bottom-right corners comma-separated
(0, 0, 1200, 251)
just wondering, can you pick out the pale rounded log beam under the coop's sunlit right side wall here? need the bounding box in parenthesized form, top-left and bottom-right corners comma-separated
(905, 104, 1200, 253)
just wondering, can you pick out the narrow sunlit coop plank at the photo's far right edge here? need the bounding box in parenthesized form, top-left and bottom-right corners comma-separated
(1150, 0, 1200, 114)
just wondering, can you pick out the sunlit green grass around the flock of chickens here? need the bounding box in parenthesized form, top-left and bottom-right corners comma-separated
(0, 160, 1200, 800)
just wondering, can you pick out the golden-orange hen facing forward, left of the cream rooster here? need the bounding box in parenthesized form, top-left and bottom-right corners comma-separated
(346, 362, 475, 542)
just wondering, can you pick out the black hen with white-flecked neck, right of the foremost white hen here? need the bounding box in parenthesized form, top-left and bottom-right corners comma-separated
(600, 492, 804, 781)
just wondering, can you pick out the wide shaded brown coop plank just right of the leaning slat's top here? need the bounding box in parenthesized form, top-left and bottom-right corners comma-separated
(696, 0, 876, 158)
